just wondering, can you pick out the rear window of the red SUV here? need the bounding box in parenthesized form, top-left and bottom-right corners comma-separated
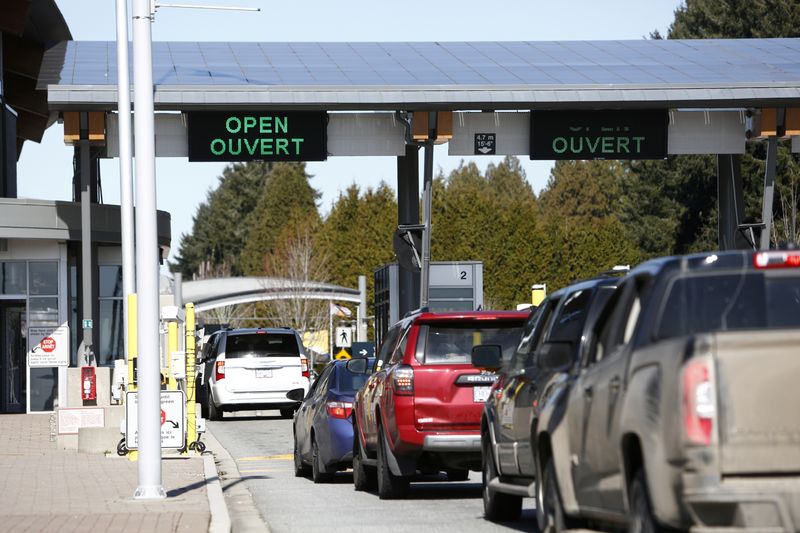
(416, 322, 522, 365)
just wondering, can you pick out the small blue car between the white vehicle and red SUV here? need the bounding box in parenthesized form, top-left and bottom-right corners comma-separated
(294, 359, 374, 483)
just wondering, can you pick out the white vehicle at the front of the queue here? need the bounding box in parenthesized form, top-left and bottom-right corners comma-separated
(197, 328, 309, 420)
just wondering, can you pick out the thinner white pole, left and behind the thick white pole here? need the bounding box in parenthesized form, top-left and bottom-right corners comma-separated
(117, 0, 136, 361)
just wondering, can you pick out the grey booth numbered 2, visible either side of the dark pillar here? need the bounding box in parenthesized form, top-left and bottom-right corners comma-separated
(375, 261, 483, 347)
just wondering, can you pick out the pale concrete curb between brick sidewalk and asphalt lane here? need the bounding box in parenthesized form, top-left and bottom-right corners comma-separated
(203, 426, 270, 533)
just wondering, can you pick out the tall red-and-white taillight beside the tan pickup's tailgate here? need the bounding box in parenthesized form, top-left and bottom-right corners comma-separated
(683, 358, 717, 446)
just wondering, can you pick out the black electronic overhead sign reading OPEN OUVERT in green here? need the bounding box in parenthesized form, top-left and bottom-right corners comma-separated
(187, 111, 328, 161)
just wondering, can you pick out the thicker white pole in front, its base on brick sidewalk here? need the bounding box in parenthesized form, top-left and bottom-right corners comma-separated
(133, 0, 166, 499)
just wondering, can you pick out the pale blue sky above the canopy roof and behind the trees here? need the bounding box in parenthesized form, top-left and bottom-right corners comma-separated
(17, 0, 682, 259)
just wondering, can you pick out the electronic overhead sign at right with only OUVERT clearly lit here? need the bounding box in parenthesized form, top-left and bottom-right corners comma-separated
(530, 109, 669, 160)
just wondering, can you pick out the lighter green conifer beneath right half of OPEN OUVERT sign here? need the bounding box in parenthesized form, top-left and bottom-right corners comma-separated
(239, 163, 320, 276)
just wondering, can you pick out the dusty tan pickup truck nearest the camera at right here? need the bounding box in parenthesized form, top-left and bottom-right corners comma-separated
(535, 251, 800, 531)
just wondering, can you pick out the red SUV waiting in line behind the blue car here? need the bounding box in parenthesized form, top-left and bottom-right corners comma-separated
(348, 311, 528, 499)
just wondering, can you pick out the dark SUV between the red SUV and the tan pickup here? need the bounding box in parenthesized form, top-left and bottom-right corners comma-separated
(473, 275, 619, 521)
